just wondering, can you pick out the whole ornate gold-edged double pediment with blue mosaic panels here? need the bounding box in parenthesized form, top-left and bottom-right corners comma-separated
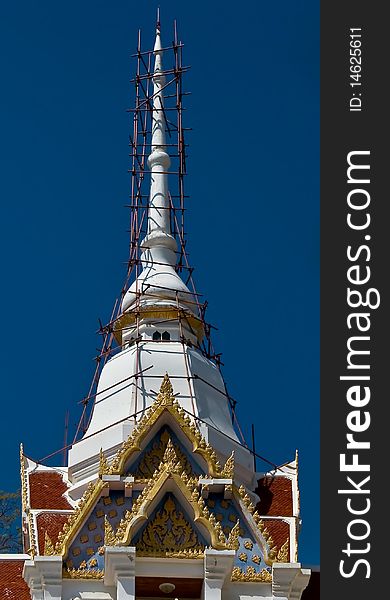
(45, 376, 288, 581)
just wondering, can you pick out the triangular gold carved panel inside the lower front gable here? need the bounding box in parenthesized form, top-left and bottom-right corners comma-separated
(136, 496, 204, 556)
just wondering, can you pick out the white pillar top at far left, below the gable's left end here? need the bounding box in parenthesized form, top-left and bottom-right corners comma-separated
(23, 556, 62, 600)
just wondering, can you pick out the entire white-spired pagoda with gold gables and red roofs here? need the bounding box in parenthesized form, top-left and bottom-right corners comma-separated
(0, 16, 310, 600)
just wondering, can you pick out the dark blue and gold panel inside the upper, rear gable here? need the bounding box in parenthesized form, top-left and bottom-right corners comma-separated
(127, 425, 203, 479)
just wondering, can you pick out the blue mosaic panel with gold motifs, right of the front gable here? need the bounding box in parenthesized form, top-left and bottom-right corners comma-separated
(206, 493, 268, 573)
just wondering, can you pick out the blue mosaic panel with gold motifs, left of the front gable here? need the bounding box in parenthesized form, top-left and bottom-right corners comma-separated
(65, 490, 132, 570)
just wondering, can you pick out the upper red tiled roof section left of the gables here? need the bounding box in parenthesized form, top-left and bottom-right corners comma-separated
(29, 471, 73, 510)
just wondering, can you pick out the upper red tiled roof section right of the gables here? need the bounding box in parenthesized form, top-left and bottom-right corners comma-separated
(255, 476, 293, 517)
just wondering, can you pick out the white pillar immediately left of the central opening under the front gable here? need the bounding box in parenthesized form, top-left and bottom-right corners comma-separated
(104, 546, 135, 600)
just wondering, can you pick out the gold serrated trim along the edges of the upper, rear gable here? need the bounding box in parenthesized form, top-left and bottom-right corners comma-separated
(109, 373, 222, 478)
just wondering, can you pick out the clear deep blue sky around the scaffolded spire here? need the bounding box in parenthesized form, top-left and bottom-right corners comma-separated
(0, 0, 319, 564)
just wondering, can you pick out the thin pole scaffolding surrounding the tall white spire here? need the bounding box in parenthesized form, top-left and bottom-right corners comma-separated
(69, 21, 246, 445)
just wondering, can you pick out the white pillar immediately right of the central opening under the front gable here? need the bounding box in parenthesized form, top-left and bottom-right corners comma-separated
(202, 549, 236, 600)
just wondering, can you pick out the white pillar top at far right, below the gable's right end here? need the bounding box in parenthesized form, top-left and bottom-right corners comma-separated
(272, 563, 311, 600)
